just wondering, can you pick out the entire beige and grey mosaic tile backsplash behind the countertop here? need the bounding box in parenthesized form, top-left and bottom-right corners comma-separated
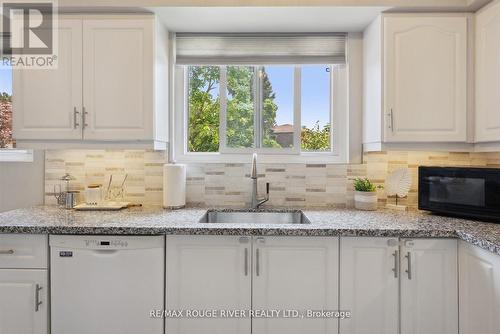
(45, 150, 500, 208)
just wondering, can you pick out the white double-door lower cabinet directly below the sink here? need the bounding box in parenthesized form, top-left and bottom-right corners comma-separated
(166, 236, 338, 334)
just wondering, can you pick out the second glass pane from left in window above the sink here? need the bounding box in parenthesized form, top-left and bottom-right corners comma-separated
(226, 66, 255, 148)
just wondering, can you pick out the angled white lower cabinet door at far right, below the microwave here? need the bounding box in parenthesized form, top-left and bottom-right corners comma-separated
(458, 241, 500, 334)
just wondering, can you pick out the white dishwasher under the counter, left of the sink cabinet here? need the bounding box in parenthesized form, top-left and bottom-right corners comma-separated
(49, 235, 165, 334)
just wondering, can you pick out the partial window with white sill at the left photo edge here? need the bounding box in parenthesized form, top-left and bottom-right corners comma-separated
(0, 66, 33, 162)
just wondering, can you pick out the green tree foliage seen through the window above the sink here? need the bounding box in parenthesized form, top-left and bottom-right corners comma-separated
(188, 66, 331, 152)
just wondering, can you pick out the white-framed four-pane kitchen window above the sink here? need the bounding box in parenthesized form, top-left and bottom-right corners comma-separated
(173, 36, 347, 161)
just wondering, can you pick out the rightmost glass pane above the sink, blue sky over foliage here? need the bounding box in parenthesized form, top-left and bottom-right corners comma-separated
(301, 65, 331, 151)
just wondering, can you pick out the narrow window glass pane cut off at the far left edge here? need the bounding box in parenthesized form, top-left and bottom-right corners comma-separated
(0, 66, 15, 148)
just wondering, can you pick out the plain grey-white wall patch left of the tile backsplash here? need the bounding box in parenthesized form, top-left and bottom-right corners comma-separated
(0, 151, 45, 212)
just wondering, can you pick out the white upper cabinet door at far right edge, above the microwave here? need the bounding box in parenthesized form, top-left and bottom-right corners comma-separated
(476, 1, 500, 142)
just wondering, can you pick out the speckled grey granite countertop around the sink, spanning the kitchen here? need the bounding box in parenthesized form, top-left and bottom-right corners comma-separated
(0, 206, 500, 255)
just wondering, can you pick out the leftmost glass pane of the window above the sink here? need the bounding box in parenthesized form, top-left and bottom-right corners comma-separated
(188, 66, 220, 152)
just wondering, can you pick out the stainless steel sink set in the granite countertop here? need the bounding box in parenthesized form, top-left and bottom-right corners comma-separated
(199, 210, 311, 225)
